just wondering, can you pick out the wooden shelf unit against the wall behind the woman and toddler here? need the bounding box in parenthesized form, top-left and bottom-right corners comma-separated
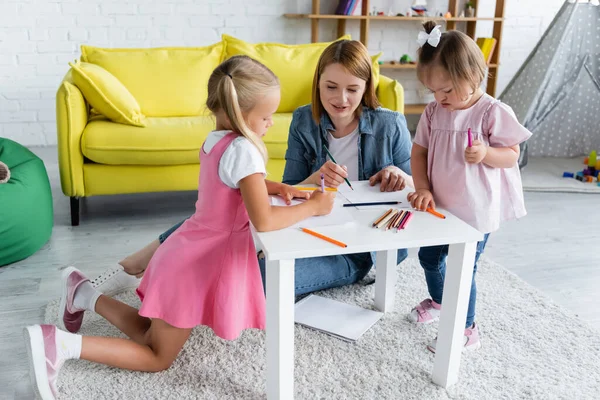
(283, 0, 505, 114)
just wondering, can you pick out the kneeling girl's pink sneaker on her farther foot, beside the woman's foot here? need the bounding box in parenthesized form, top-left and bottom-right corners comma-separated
(58, 267, 89, 333)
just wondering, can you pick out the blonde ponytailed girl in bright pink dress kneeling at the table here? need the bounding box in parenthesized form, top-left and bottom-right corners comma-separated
(25, 56, 334, 399)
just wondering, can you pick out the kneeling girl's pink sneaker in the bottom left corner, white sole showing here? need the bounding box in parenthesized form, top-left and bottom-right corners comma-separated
(23, 325, 65, 400)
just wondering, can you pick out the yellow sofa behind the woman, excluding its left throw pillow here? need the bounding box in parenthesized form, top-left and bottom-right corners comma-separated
(56, 35, 404, 225)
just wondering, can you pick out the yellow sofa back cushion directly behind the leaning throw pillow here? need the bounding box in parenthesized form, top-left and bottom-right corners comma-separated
(81, 42, 223, 117)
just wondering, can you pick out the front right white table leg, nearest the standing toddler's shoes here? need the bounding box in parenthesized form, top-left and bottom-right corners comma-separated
(432, 242, 477, 388)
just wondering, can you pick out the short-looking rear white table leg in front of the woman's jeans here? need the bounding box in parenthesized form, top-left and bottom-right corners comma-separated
(375, 250, 398, 312)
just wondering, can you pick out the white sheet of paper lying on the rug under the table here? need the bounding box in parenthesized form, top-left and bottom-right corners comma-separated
(294, 295, 383, 341)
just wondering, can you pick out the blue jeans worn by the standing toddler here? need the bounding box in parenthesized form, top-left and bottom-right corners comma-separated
(419, 233, 490, 328)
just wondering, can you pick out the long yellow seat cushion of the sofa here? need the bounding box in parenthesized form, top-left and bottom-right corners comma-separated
(81, 113, 292, 165)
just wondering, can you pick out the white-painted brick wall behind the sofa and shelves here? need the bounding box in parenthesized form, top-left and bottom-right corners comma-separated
(0, 0, 563, 145)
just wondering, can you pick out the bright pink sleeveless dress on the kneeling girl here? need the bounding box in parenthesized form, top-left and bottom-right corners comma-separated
(137, 133, 266, 340)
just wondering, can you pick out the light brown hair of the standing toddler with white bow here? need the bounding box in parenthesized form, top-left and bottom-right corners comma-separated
(417, 21, 486, 96)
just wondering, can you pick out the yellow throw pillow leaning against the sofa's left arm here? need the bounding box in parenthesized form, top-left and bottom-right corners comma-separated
(69, 61, 146, 126)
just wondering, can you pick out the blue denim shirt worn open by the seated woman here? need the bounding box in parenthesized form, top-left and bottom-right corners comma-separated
(283, 104, 412, 185)
